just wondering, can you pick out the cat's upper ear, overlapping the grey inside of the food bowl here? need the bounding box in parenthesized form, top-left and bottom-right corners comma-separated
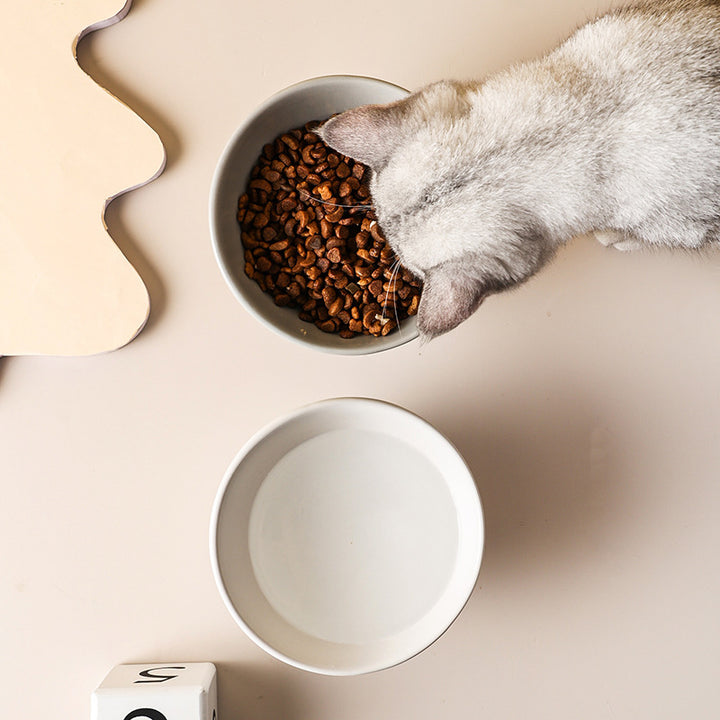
(316, 100, 405, 169)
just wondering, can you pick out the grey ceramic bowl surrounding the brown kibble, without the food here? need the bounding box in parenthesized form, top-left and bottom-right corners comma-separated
(210, 75, 417, 355)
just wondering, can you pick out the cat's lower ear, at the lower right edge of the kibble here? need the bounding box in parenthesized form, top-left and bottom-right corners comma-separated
(418, 259, 507, 340)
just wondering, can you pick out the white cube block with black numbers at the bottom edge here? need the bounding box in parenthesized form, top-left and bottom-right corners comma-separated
(91, 663, 217, 720)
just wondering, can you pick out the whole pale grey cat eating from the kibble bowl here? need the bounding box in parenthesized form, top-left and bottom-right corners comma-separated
(319, 0, 720, 338)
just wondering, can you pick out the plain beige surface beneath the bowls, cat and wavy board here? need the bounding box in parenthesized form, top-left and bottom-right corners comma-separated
(0, 0, 720, 720)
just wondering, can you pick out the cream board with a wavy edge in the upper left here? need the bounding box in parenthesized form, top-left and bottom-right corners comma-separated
(0, 0, 165, 355)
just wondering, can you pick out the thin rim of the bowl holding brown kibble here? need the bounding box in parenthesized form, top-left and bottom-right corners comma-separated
(208, 74, 419, 356)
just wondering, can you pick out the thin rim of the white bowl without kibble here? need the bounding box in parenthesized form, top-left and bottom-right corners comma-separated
(209, 396, 486, 676)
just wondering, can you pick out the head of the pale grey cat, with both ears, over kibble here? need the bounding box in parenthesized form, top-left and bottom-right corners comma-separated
(318, 82, 552, 338)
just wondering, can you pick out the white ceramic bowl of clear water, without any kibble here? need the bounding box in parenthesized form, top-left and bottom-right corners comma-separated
(210, 398, 484, 675)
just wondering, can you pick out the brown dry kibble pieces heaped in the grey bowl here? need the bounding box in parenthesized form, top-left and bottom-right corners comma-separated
(238, 123, 421, 338)
